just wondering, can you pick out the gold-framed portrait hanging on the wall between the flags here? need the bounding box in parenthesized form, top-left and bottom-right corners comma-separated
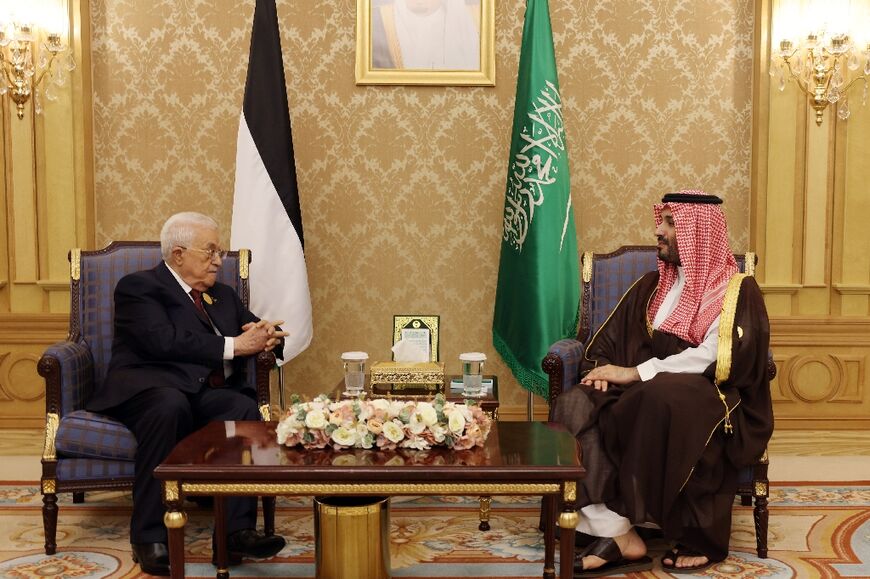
(356, 0, 495, 86)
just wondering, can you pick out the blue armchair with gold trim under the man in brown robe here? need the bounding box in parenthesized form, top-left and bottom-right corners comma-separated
(541, 246, 776, 558)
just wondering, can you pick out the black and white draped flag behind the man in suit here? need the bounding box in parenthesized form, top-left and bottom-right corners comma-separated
(230, 0, 312, 364)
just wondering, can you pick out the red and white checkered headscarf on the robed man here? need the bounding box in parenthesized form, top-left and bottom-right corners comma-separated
(648, 189, 737, 346)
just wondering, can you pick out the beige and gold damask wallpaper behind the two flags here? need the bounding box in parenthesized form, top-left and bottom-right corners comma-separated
(90, 0, 753, 405)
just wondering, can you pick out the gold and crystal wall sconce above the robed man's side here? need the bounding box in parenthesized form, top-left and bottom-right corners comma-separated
(770, 17, 870, 126)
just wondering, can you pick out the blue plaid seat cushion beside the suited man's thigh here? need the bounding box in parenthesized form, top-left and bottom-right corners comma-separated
(55, 410, 136, 461)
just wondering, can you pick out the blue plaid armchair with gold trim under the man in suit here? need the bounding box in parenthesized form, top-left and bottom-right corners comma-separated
(38, 241, 275, 555)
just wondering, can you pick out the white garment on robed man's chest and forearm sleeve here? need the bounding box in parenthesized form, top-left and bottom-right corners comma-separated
(637, 266, 719, 381)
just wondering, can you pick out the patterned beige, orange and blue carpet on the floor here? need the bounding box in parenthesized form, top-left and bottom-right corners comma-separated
(0, 482, 870, 579)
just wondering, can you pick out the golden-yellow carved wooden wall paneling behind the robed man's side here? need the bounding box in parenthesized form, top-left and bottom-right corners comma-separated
(750, 0, 870, 429)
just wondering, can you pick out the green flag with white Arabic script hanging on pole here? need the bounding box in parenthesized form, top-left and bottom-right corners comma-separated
(492, 0, 580, 396)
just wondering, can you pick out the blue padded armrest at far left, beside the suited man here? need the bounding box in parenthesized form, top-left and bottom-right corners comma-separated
(37, 341, 94, 416)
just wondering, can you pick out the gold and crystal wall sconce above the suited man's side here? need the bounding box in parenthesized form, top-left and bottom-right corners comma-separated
(0, 14, 76, 119)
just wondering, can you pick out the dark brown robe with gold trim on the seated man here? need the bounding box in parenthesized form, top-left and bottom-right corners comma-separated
(555, 272, 773, 561)
